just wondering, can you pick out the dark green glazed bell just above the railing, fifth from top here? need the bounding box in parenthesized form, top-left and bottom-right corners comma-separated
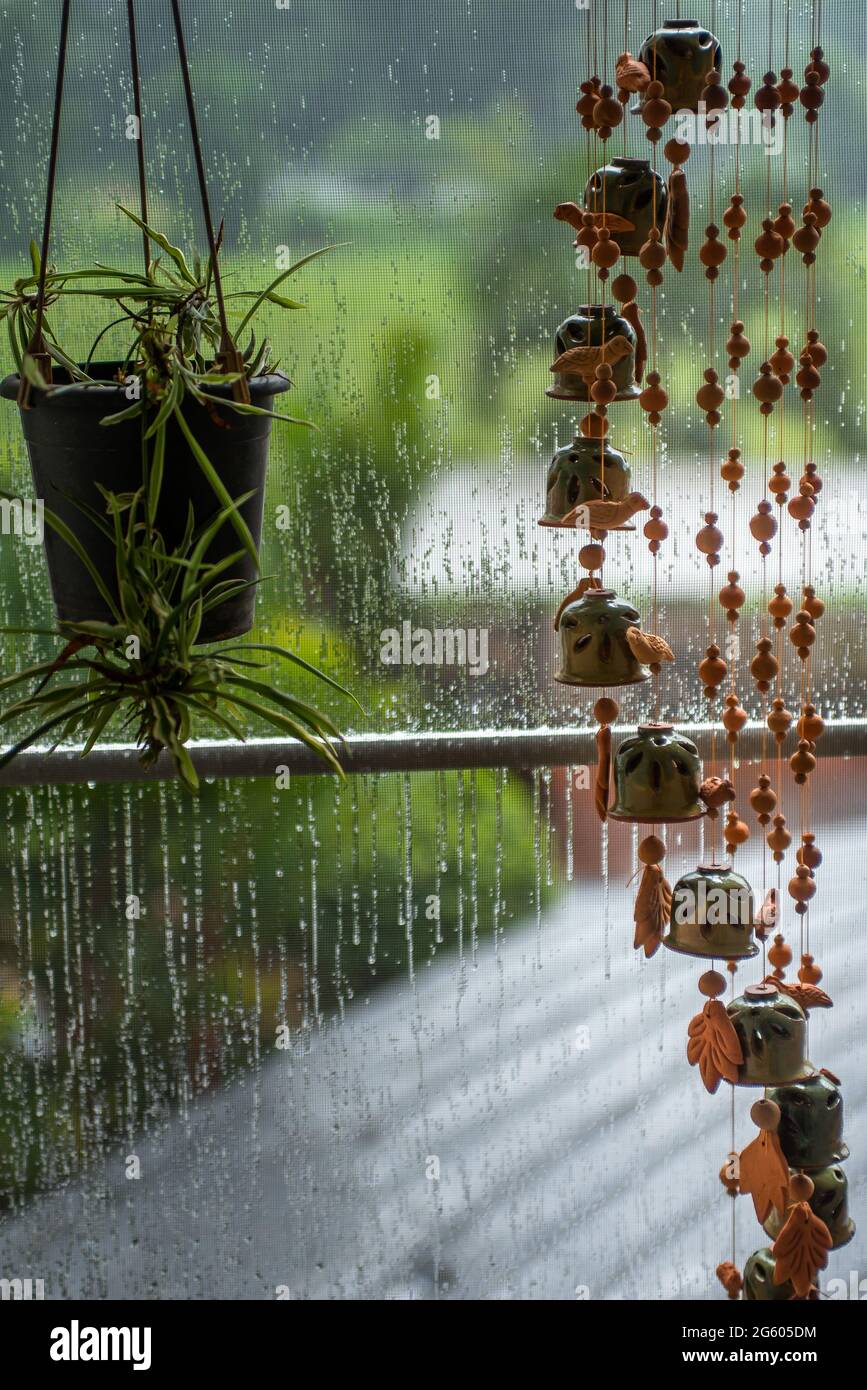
(554, 589, 647, 687)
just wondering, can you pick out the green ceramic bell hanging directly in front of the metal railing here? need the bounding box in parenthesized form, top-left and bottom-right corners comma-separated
(609, 724, 704, 824)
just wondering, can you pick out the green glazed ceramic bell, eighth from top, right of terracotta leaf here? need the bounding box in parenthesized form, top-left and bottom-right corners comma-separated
(727, 983, 814, 1086)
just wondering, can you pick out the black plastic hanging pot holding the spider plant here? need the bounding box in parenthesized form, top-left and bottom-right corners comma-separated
(0, 363, 290, 642)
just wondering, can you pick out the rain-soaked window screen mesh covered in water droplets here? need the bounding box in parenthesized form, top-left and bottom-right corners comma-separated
(0, 0, 867, 1298)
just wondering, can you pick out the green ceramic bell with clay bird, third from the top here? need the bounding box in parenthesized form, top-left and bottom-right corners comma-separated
(546, 304, 641, 400)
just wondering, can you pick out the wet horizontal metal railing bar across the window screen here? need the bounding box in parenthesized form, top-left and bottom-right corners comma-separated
(0, 719, 867, 787)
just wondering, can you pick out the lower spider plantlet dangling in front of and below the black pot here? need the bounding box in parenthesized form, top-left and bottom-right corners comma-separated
(0, 488, 360, 792)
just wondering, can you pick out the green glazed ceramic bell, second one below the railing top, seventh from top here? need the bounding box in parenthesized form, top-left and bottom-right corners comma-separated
(663, 865, 759, 960)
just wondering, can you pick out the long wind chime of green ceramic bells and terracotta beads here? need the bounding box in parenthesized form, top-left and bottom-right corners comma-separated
(539, 0, 854, 1300)
